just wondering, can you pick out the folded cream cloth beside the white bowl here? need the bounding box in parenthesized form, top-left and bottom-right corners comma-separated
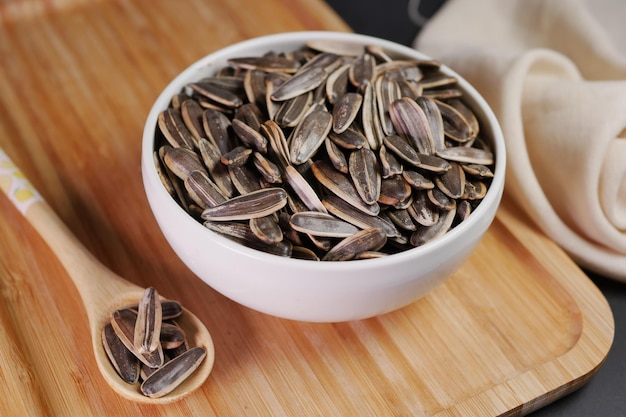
(414, 0, 626, 282)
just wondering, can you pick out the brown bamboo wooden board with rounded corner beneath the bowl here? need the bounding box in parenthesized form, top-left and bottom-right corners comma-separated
(0, 0, 614, 417)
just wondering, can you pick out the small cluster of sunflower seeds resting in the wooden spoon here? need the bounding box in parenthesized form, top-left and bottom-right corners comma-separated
(102, 287, 206, 398)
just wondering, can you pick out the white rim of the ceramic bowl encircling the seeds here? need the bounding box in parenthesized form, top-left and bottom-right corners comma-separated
(141, 31, 506, 272)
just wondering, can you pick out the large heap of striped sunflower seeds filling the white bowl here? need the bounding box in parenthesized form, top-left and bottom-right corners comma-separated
(154, 41, 495, 261)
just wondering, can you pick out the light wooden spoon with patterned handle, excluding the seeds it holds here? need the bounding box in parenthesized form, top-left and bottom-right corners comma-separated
(0, 148, 215, 404)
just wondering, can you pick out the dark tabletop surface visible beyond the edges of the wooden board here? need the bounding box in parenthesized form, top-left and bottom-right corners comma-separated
(327, 0, 626, 417)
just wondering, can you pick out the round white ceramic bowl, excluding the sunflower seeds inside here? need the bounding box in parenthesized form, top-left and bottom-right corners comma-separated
(142, 32, 505, 322)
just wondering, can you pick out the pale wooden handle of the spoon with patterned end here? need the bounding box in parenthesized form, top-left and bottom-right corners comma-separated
(0, 148, 132, 312)
